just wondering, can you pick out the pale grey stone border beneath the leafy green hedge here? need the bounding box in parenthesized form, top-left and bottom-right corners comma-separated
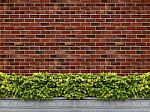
(0, 97, 150, 112)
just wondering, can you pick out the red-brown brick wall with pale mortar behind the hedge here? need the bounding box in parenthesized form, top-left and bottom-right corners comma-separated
(0, 0, 150, 75)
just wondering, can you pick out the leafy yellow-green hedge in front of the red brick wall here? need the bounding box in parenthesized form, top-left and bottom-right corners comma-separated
(0, 73, 150, 100)
